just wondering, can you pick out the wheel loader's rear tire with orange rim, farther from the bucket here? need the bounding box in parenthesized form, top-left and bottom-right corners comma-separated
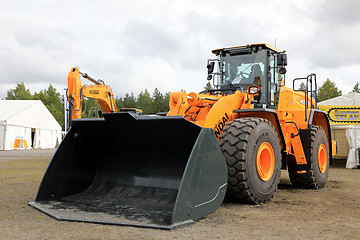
(288, 126, 330, 189)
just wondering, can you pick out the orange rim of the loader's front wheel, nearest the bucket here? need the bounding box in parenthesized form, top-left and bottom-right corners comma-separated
(256, 142, 275, 181)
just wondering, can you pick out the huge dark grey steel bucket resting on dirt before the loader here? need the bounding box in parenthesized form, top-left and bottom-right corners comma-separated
(29, 113, 227, 229)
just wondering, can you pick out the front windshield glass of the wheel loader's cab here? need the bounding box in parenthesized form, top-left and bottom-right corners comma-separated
(220, 50, 266, 89)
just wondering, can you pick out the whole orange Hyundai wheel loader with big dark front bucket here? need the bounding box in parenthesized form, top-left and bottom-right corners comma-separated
(30, 44, 333, 229)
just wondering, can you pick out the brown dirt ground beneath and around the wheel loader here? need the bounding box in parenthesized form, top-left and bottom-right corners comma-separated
(0, 150, 360, 240)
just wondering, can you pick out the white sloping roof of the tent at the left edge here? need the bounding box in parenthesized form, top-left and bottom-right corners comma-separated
(0, 100, 61, 130)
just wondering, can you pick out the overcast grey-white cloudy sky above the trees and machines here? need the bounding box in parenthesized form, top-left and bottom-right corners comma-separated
(0, 0, 360, 99)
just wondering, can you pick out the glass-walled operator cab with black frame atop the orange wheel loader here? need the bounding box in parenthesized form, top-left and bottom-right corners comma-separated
(208, 44, 287, 108)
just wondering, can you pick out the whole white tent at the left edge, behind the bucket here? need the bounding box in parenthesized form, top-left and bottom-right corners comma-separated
(0, 100, 61, 150)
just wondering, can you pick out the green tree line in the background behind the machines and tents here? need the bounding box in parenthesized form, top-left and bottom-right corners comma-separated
(5, 79, 360, 130)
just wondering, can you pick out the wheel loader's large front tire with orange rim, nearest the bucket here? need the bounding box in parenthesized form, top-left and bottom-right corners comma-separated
(219, 118, 281, 204)
